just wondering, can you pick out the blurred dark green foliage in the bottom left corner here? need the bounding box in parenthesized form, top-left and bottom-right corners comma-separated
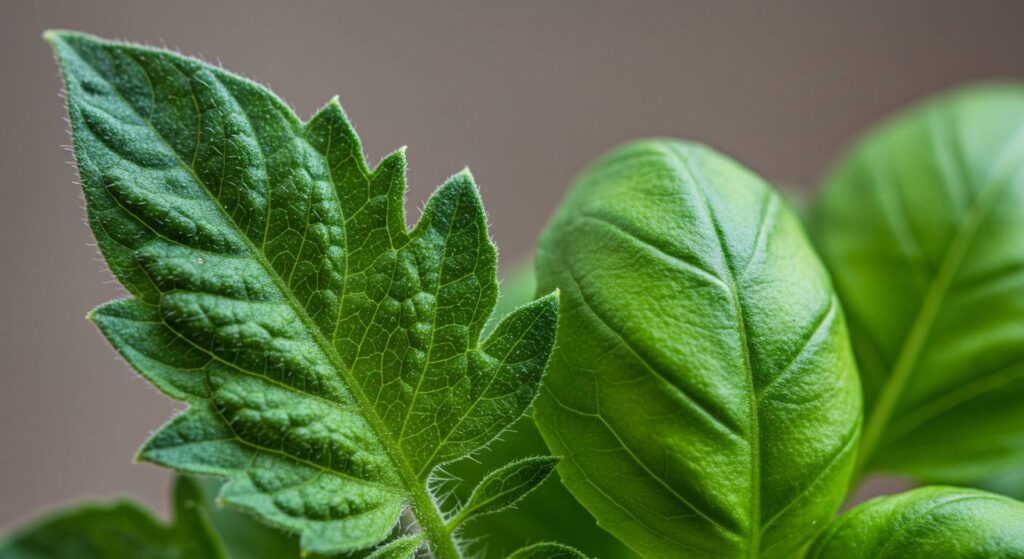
(0, 477, 227, 559)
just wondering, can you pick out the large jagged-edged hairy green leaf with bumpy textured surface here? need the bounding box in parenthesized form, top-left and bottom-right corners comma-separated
(47, 33, 557, 558)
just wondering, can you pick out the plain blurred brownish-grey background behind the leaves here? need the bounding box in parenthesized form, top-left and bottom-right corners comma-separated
(0, 0, 1024, 529)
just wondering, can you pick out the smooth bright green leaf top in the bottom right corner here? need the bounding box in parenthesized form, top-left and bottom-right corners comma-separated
(807, 486, 1024, 559)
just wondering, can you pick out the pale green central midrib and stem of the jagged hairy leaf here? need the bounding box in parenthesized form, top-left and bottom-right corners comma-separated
(75, 42, 462, 559)
